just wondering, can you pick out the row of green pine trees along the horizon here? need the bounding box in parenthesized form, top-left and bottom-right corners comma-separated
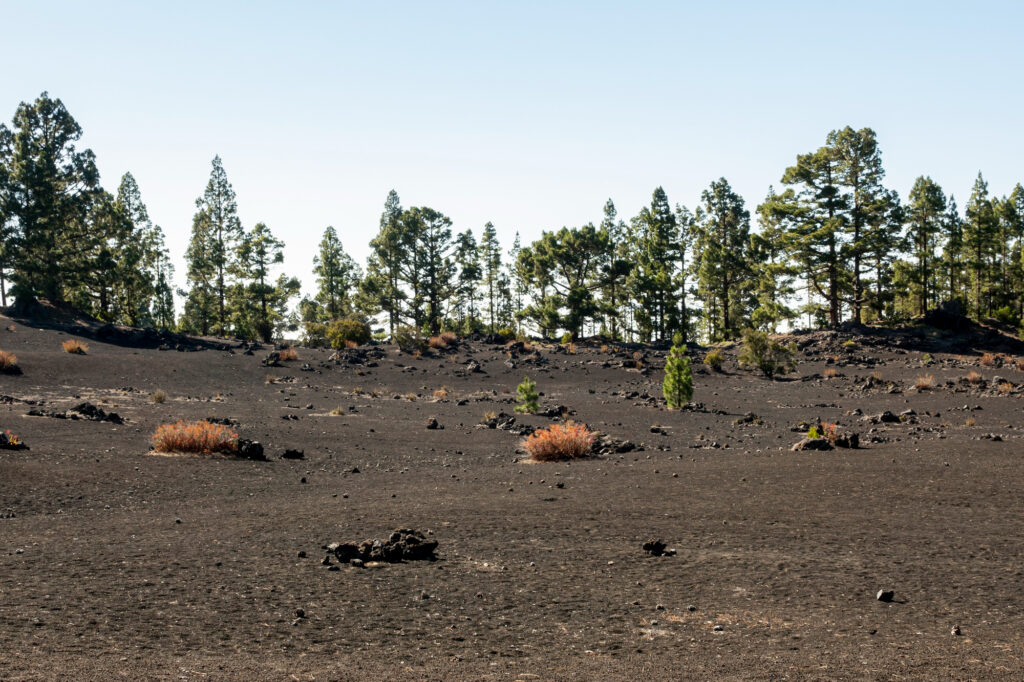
(0, 93, 1024, 342)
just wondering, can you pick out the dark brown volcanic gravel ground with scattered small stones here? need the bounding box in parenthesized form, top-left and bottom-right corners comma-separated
(0, 318, 1024, 680)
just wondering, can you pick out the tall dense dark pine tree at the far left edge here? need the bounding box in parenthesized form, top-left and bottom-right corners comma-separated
(0, 92, 101, 303)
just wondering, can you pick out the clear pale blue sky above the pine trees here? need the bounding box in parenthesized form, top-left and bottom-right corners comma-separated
(0, 0, 1024, 301)
